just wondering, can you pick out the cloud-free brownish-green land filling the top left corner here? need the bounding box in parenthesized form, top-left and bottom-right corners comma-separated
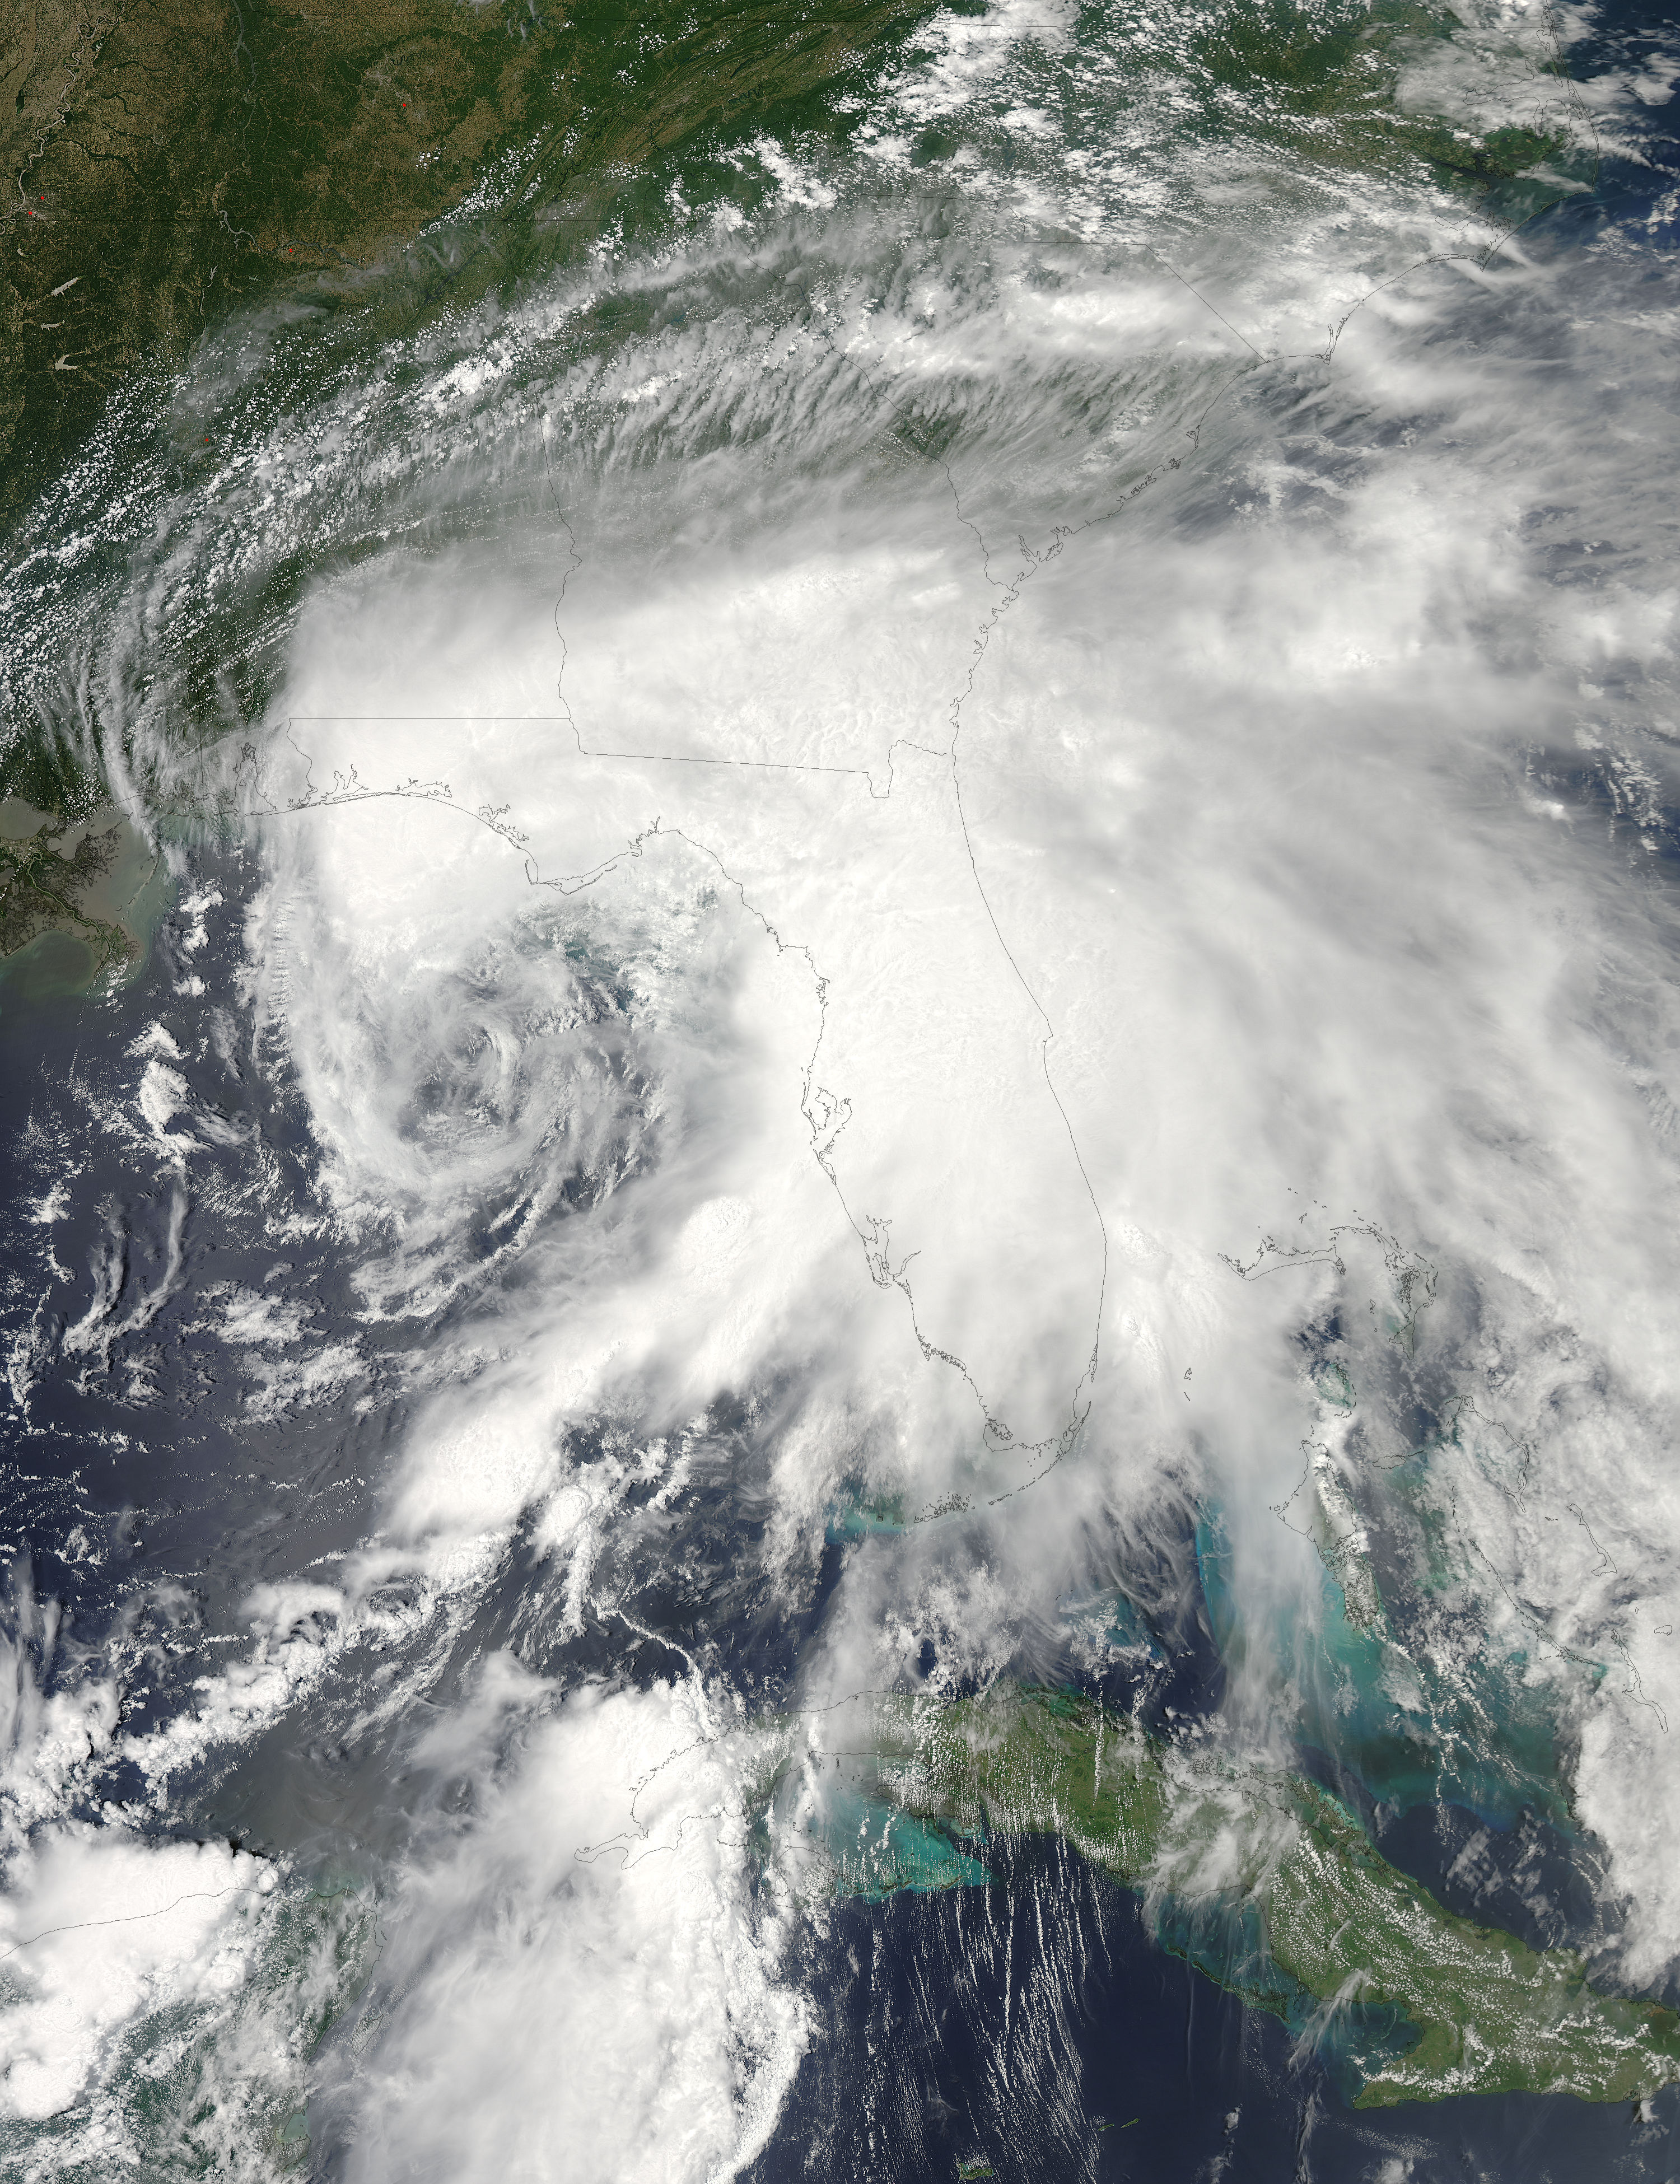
(0, 0, 944, 524)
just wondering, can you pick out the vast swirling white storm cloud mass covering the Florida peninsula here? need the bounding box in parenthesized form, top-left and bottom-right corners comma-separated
(0, 0, 1680, 2184)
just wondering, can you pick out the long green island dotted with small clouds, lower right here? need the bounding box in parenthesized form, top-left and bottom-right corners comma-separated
(852, 1691, 1680, 2108)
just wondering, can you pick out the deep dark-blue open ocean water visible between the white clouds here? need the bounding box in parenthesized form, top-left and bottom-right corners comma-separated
(0, 4, 1680, 2184)
